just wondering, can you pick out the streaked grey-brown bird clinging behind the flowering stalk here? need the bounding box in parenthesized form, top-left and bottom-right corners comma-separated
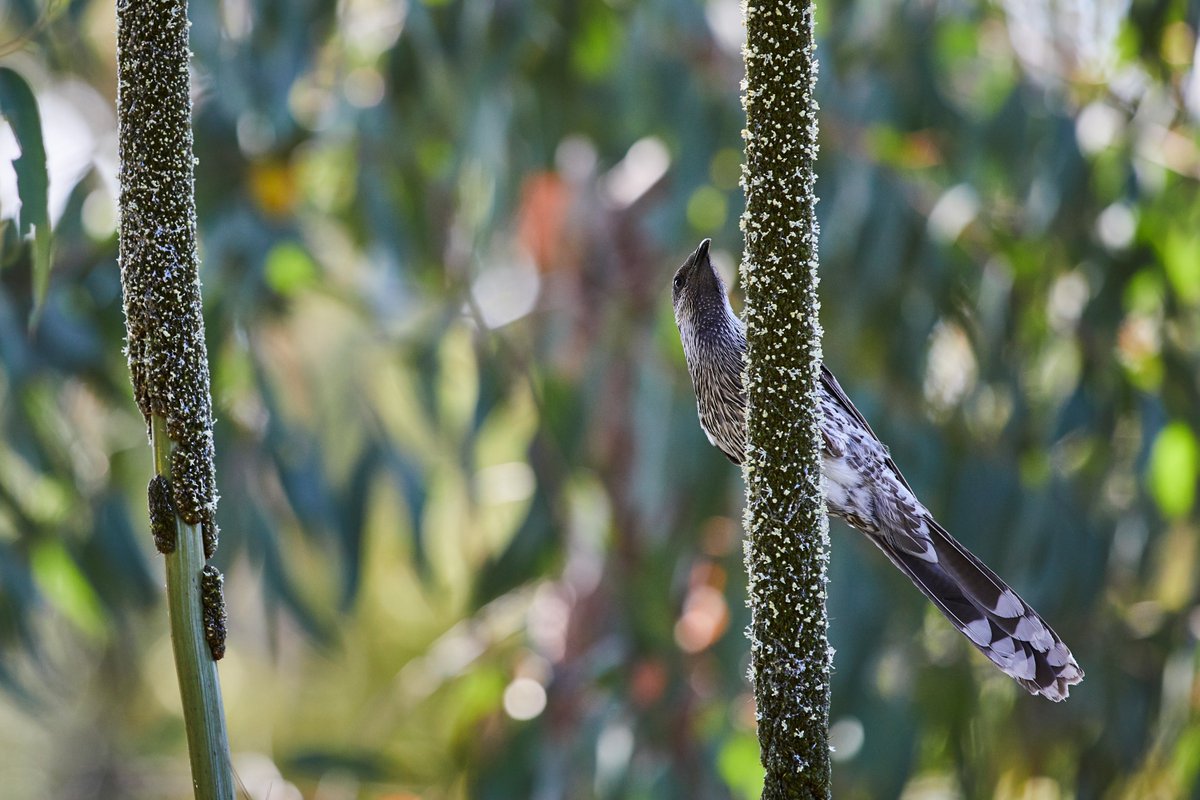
(671, 239, 1084, 702)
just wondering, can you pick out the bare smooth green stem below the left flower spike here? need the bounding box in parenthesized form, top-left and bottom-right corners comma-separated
(151, 416, 234, 800)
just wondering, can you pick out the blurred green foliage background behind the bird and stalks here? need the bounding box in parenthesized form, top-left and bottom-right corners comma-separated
(0, 0, 1200, 800)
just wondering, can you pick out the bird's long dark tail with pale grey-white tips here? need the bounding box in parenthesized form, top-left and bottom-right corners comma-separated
(870, 518, 1084, 703)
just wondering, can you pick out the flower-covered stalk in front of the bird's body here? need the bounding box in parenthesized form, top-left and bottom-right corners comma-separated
(742, 0, 833, 800)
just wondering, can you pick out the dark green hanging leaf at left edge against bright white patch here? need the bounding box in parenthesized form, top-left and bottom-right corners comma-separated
(0, 67, 52, 329)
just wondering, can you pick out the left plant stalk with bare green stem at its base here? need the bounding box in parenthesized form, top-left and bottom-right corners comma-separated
(116, 0, 234, 800)
